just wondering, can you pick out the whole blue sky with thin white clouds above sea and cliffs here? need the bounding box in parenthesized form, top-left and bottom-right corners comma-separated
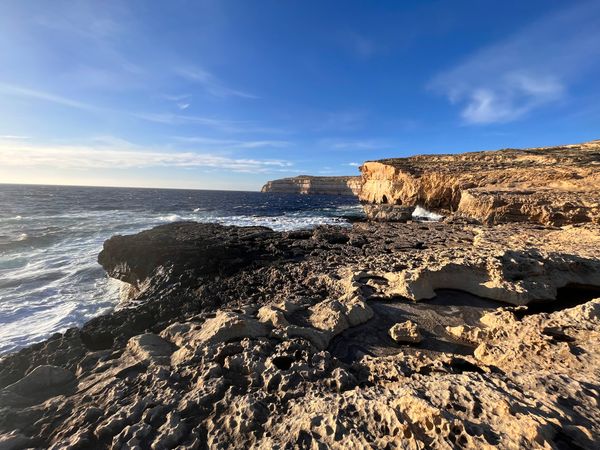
(0, 0, 600, 190)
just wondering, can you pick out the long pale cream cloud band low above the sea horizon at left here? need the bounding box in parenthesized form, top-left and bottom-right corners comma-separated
(0, 142, 293, 173)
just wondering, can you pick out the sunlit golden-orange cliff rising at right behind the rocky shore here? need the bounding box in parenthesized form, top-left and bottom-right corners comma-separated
(360, 140, 600, 226)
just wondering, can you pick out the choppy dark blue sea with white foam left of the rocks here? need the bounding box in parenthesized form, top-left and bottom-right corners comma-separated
(0, 184, 362, 354)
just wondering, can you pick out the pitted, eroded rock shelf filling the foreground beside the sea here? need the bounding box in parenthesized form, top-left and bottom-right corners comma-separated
(0, 219, 600, 449)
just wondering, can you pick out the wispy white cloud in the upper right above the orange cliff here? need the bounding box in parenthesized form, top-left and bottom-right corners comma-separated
(430, 1, 600, 124)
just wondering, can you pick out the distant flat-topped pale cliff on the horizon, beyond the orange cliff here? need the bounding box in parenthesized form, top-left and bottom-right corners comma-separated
(261, 175, 361, 195)
